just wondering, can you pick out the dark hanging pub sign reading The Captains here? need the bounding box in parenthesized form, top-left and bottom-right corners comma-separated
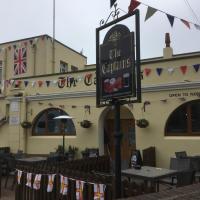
(96, 10, 141, 106)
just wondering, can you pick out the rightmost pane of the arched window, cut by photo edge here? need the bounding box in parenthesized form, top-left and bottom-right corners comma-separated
(191, 102, 200, 132)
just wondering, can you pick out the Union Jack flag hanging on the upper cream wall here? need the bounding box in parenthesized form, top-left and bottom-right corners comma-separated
(14, 48, 27, 75)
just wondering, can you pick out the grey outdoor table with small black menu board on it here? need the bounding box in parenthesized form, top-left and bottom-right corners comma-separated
(121, 166, 178, 192)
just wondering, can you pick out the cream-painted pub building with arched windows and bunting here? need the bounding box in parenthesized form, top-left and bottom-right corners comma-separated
(0, 34, 200, 168)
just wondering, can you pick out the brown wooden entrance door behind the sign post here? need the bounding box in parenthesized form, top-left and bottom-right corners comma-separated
(104, 119, 135, 169)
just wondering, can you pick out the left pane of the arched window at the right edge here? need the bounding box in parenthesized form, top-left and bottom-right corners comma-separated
(167, 105, 187, 133)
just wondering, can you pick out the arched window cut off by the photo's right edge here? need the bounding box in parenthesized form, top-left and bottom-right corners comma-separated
(165, 100, 200, 136)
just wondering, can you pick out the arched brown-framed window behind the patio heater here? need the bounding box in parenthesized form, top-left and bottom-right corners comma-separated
(33, 108, 76, 136)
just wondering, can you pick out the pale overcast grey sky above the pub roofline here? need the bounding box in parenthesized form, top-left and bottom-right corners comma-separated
(0, 0, 200, 64)
